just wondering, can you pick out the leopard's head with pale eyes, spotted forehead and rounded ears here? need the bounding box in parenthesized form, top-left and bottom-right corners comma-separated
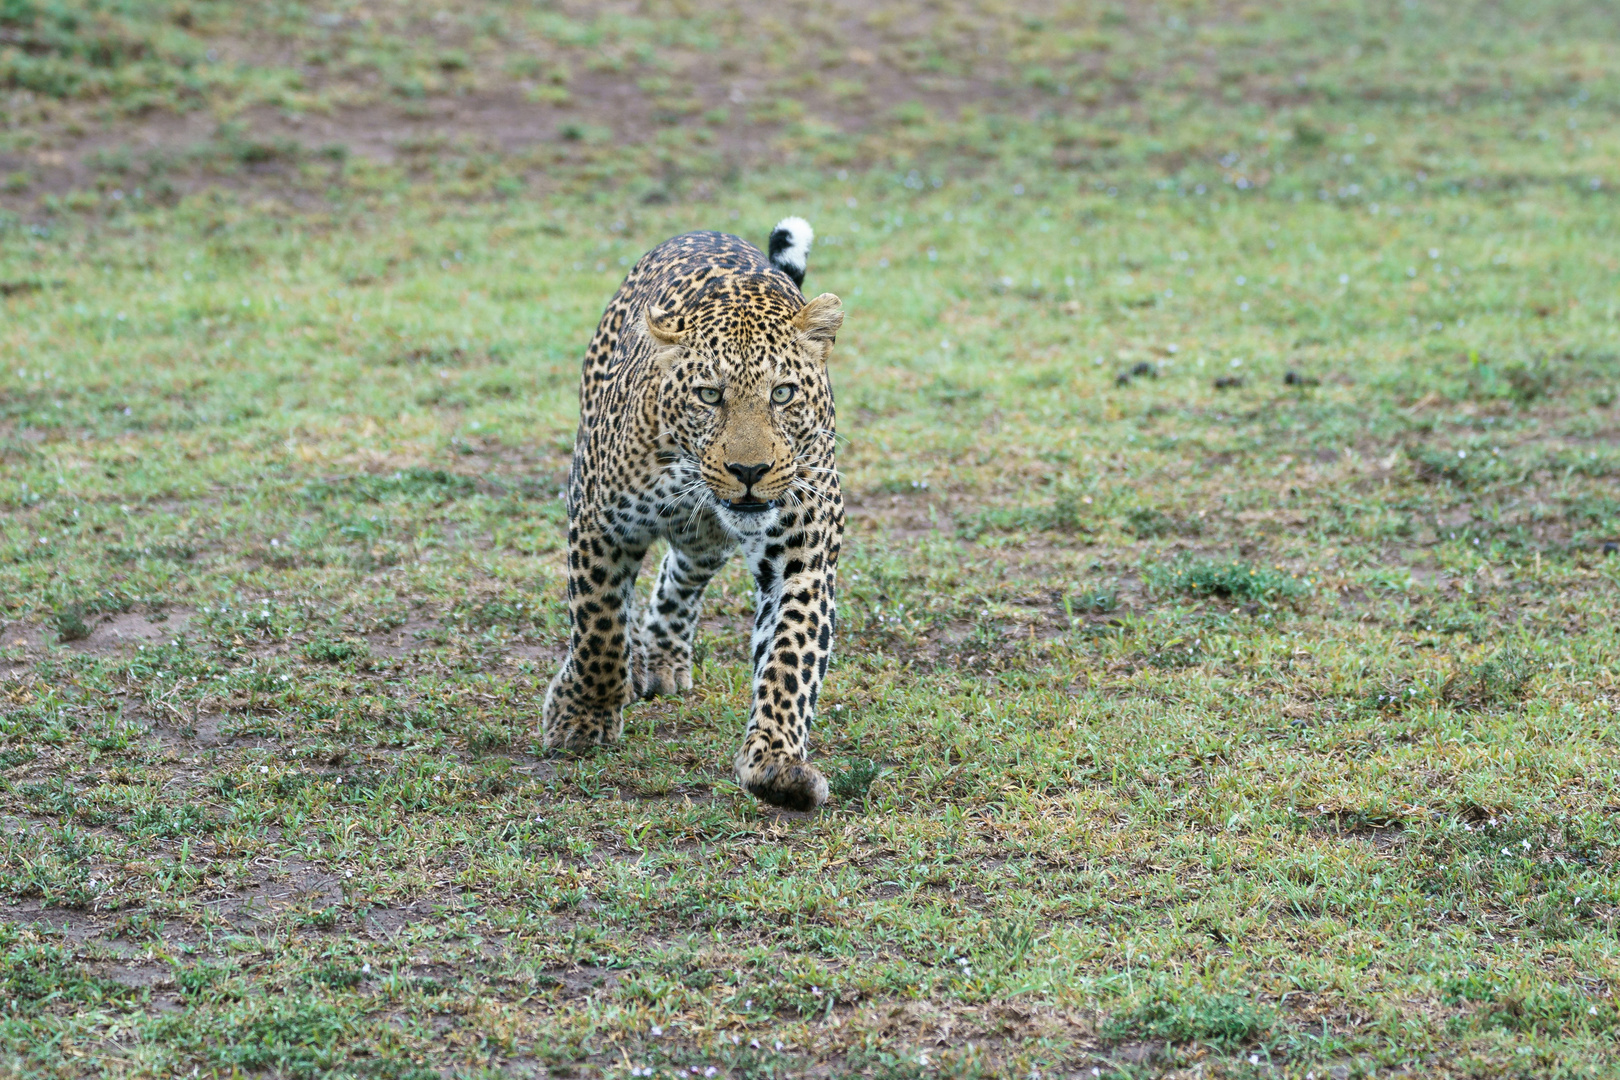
(645, 275, 844, 529)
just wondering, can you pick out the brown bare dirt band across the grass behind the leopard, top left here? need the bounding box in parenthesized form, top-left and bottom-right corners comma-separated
(0, 2, 1050, 209)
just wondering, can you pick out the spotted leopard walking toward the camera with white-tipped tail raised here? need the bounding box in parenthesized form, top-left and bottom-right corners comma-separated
(539, 217, 844, 811)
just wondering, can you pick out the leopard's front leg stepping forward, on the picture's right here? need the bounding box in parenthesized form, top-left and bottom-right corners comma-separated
(735, 491, 844, 810)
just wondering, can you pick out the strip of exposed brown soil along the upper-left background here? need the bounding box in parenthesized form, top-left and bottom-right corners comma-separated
(0, 0, 1134, 212)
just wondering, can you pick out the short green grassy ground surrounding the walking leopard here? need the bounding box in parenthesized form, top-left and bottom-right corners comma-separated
(0, 0, 1620, 1080)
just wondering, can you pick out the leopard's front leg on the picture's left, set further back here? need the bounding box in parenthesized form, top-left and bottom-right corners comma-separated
(541, 520, 646, 750)
